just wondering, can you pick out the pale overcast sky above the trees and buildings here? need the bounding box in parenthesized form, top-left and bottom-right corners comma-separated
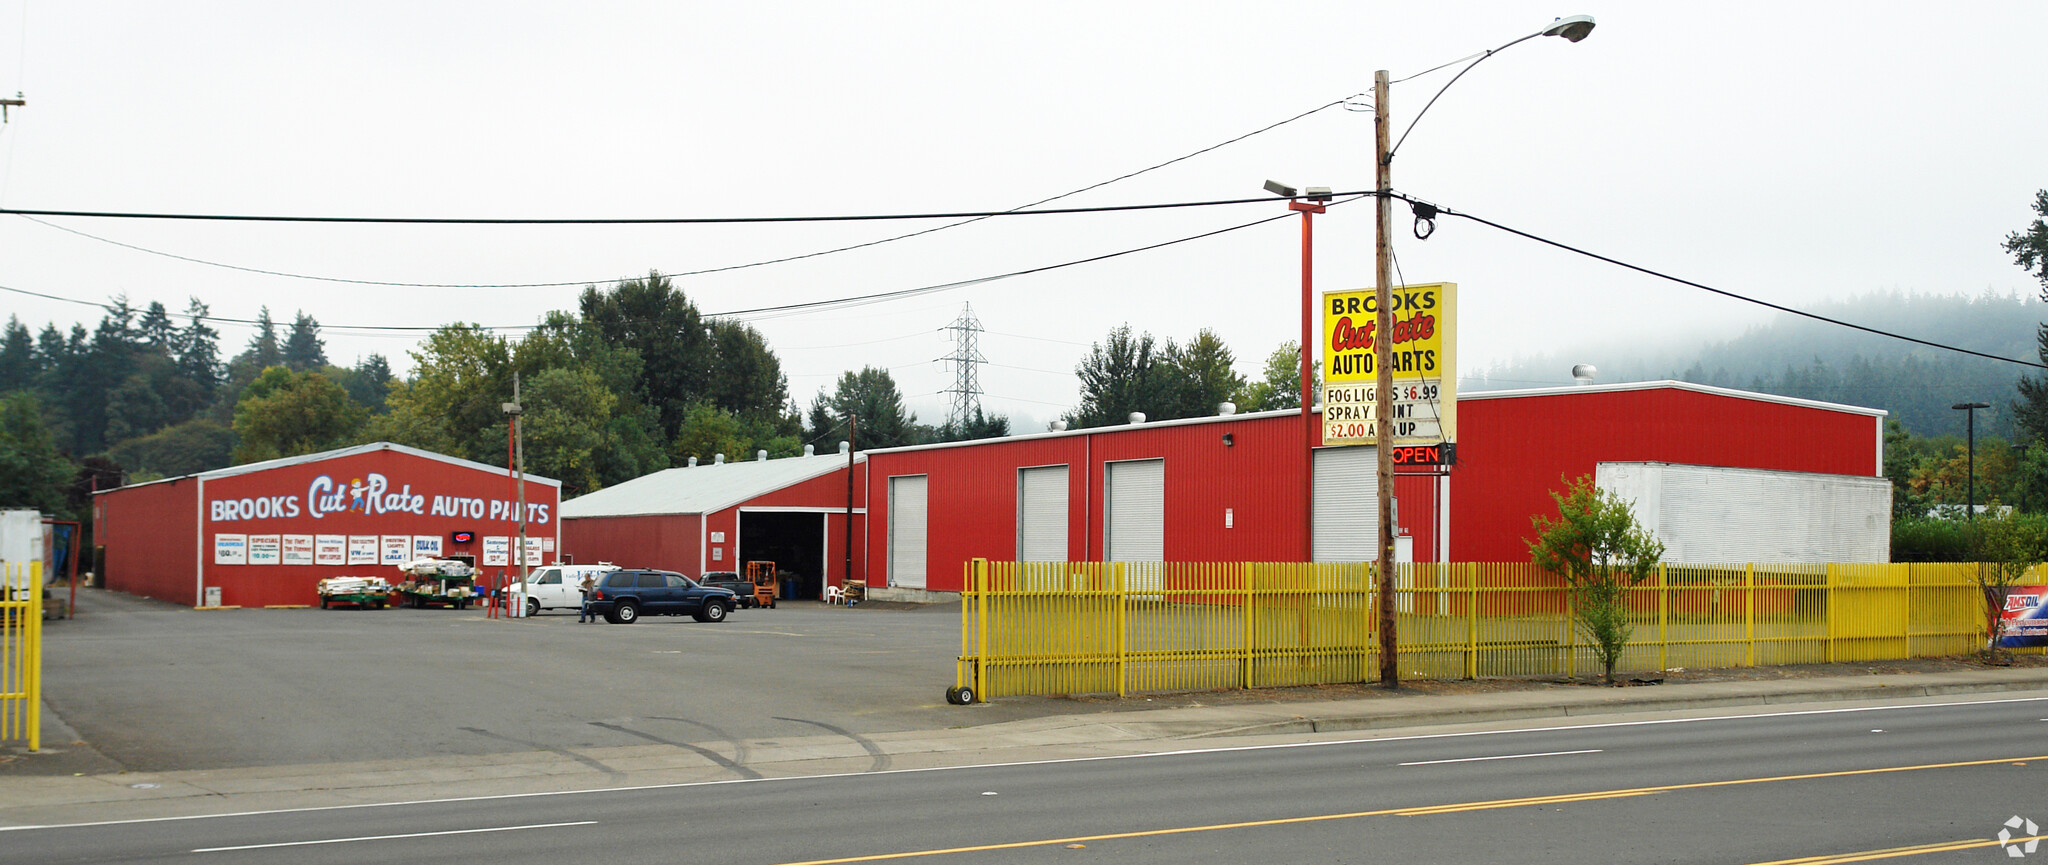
(0, 0, 2048, 428)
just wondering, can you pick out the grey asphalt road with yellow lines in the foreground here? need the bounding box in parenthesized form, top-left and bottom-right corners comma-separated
(0, 697, 2048, 865)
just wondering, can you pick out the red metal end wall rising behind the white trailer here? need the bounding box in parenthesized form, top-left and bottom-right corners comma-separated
(1449, 387, 1882, 562)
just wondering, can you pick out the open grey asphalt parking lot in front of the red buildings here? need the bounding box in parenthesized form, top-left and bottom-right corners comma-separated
(0, 590, 1048, 775)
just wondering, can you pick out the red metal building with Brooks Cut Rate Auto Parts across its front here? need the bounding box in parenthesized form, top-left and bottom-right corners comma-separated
(94, 443, 561, 607)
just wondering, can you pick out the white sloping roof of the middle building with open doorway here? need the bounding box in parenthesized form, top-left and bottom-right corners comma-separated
(561, 453, 866, 519)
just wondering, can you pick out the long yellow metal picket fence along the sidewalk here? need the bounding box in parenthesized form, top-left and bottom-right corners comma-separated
(956, 560, 2038, 699)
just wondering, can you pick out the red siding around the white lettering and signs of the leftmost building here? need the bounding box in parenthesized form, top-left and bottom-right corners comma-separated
(102, 451, 559, 607)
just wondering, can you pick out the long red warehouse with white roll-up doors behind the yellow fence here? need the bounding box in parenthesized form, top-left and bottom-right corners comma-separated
(854, 381, 1890, 599)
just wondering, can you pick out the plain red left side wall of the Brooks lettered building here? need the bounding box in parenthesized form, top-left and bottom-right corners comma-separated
(94, 478, 201, 607)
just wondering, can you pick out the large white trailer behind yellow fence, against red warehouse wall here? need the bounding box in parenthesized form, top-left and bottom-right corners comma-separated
(1593, 463, 1892, 564)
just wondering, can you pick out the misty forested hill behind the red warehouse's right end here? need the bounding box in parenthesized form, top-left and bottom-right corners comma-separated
(1458, 293, 2048, 439)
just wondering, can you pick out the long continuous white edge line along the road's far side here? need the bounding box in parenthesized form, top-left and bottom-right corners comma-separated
(16, 688, 2048, 832)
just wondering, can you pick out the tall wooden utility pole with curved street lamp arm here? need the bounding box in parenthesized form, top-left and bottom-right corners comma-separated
(1376, 14, 1593, 689)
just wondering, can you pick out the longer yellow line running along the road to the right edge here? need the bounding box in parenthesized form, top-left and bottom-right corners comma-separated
(782, 756, 2048, 865)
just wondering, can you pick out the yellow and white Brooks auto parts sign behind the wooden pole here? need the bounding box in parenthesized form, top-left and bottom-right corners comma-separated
(1321, 283, 1458, 445)
